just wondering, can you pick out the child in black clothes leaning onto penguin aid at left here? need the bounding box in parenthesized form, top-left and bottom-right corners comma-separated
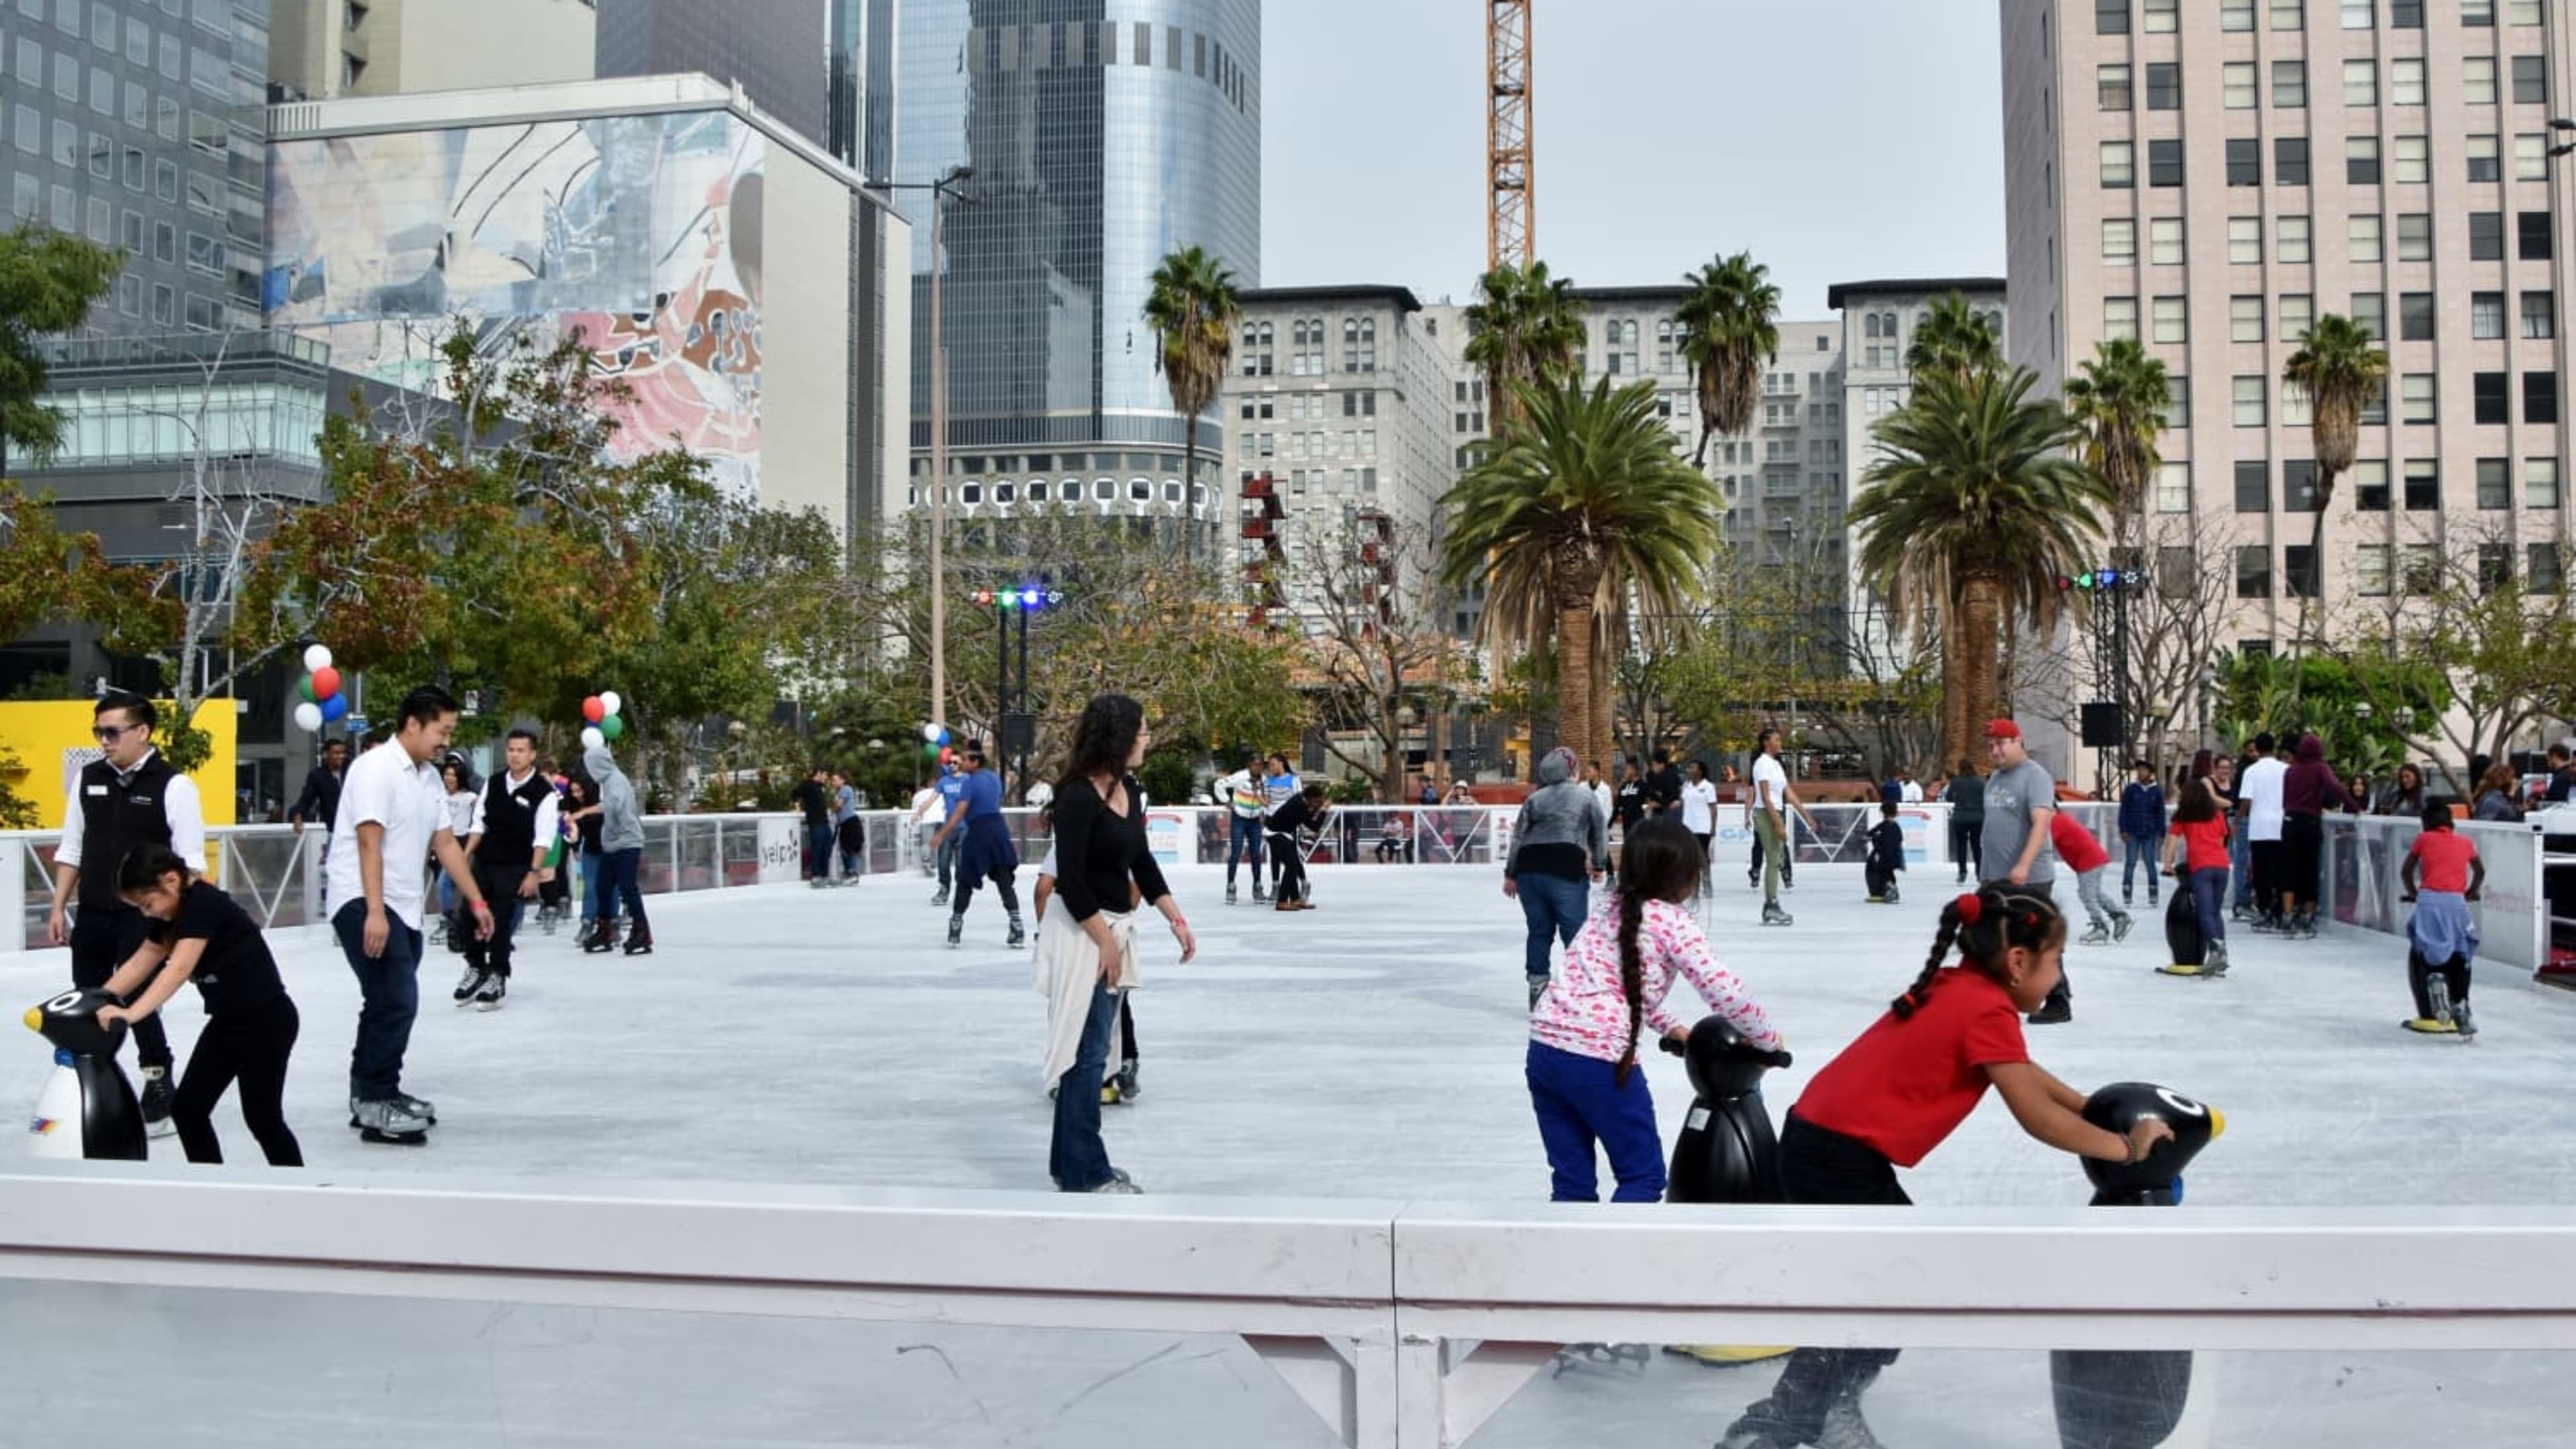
(98, 846, 304, 1168)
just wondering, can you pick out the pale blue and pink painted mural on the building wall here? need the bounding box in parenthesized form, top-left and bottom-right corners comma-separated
(263, 111, 767, 492)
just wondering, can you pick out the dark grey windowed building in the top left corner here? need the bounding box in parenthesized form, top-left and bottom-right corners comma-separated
(0, 0, 268, 335)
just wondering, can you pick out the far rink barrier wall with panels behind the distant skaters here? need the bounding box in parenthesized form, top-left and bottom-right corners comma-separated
(0, 799, 2534, 969)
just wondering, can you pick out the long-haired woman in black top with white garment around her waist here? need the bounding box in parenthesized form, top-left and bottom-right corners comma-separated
(1038, 694, 1198, 1194)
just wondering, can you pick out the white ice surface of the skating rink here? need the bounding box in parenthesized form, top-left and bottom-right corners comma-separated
(0, 866, 2576, 1449)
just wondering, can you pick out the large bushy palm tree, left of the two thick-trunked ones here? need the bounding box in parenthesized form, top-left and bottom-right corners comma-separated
(1440, 379, 1723, 761)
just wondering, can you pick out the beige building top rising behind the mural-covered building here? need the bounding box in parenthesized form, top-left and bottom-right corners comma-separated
(268, 0, 598, 101)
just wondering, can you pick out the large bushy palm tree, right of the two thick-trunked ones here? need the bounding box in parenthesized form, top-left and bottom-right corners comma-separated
(1849, 369, 2110, 761)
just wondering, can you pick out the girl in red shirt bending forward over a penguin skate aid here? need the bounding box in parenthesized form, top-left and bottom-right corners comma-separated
(1718, 881, 2174, 1449)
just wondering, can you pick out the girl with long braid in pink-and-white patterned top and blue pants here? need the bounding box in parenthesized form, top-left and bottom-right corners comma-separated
(1527, 815, 1780, 1201)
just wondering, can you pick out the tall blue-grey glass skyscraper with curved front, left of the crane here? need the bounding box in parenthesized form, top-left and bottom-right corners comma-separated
(896, 0, 1263, 536)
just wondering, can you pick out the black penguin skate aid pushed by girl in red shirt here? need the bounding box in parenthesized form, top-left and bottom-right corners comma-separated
(2048, 1083, 2226, 1449)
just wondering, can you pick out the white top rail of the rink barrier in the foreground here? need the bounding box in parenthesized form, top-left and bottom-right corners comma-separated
(0, 1163, 2576, 1449)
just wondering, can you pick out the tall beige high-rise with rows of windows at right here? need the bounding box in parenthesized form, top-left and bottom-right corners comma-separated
(2002, 0, 2576, 722)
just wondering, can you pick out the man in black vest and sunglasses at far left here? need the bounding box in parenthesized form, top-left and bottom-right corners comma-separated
(46, 694, 206, 1137)
